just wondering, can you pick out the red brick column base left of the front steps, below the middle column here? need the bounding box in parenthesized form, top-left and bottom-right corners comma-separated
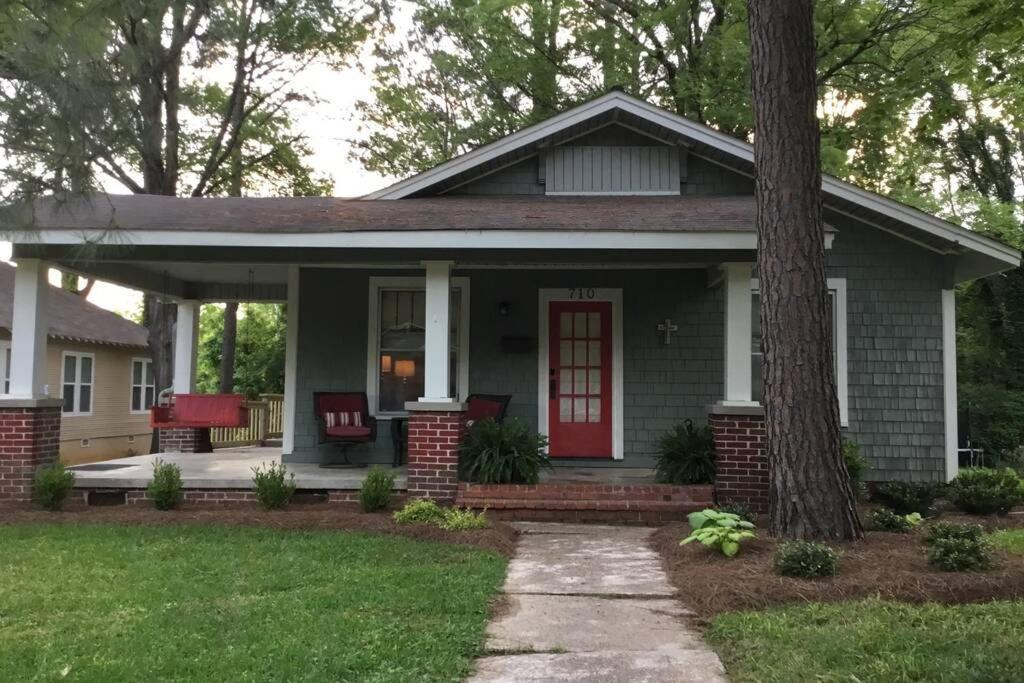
(406, 402, 466, 503)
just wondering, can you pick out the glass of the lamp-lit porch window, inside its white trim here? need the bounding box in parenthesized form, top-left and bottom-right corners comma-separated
(375, 288, 462, 413)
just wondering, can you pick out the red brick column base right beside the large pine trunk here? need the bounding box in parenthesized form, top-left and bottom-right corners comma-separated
(708, 405, 768, 514)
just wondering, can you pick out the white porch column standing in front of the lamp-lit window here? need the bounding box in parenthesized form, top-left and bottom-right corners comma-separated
(420, 261, 453, 402)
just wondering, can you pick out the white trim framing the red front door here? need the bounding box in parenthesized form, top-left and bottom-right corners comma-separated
(537, 287, 626, 460)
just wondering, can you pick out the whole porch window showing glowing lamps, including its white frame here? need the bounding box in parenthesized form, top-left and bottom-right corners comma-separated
(367, 278, 469, 415)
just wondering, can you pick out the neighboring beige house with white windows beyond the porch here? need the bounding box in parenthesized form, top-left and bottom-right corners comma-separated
(0, 263, 156, 464)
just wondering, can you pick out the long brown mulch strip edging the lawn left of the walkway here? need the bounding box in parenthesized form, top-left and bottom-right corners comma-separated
(0, 503, 519, 557)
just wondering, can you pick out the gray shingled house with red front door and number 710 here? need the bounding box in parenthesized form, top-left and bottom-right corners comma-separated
(0, 92, 1020, 505)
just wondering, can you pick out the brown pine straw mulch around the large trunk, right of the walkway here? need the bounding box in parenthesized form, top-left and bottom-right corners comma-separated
(651, 515, 1024, 621)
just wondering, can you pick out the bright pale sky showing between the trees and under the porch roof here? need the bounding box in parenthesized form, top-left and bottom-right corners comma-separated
(0, 31, 398, 314)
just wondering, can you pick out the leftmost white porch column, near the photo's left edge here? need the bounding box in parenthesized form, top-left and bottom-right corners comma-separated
(10, 258, 49, 398)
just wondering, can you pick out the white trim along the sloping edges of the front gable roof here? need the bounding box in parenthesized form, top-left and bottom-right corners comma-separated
(367, 91, 1020, 267)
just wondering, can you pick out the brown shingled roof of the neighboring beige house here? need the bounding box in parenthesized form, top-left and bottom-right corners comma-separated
(0, 262, 148, 347)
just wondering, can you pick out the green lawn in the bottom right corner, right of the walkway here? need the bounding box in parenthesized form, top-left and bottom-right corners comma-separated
(708, 600, 1024, 683)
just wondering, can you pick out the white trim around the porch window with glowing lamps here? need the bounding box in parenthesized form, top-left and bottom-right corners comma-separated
(367, 275, 470, 420)
